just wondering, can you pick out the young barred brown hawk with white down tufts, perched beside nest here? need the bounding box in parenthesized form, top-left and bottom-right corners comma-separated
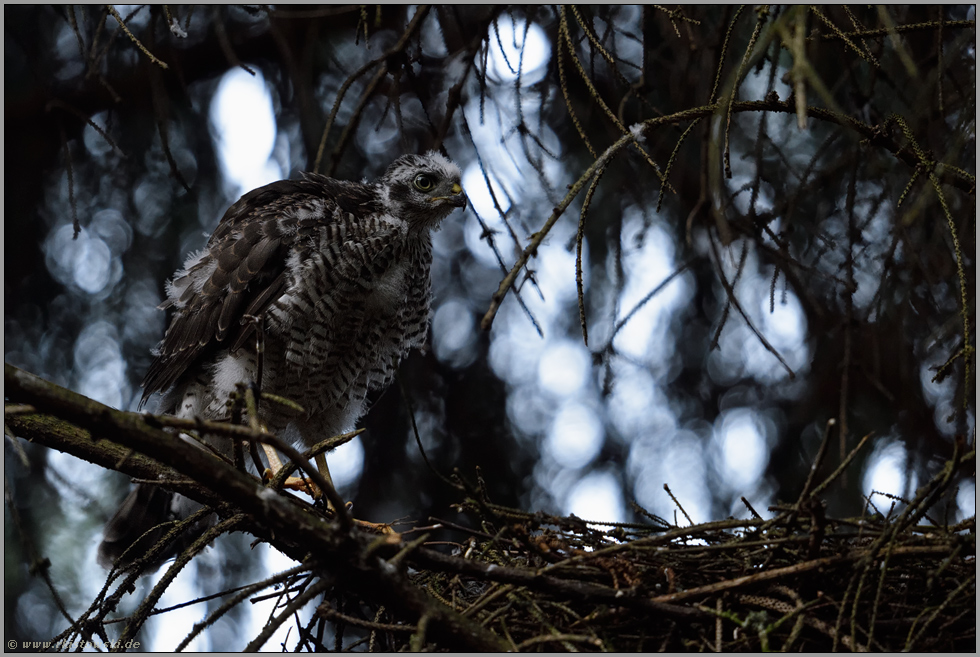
(99, 151, 466, 565)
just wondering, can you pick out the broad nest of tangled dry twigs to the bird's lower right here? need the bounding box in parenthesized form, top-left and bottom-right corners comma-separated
(328, 440, 976, 652)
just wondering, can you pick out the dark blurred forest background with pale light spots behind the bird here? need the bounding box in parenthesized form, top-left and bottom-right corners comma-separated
(4, 5, 976, 649)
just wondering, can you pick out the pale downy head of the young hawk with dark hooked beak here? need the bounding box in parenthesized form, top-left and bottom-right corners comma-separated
(378, 151, 466, 228)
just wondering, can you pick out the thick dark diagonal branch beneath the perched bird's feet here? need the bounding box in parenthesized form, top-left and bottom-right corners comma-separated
(4, 363, 507, 651)
